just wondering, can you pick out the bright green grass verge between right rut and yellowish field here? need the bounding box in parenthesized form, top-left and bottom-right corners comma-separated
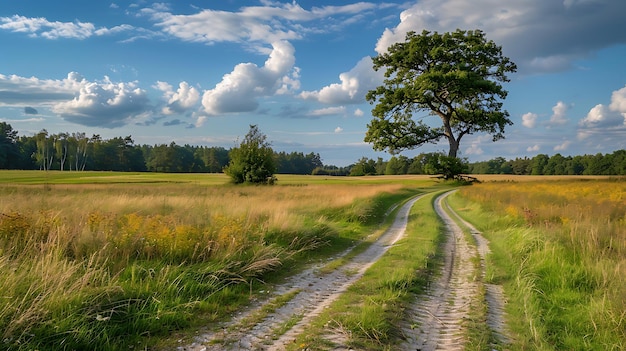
(449, 194, 626, 351)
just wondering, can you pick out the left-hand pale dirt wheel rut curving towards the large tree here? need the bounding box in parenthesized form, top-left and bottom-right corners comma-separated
(177, 196, 422, 351)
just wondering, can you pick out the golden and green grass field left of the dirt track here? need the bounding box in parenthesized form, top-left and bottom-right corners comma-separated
(0, 171, 433, 350)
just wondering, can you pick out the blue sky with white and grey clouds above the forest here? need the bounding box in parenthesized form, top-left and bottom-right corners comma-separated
(0, 0, 626, 166)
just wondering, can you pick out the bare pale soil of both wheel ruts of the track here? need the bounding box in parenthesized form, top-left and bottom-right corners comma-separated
(177, 193, 506, 351)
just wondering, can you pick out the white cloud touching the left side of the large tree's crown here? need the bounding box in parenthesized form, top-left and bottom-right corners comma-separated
(300, 56, 384, 104)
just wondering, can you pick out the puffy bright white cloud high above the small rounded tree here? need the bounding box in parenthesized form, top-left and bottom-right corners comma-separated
(202, 41, 297, 115)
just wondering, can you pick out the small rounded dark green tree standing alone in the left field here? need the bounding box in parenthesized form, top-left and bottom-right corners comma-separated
(224, 125, 276, 184)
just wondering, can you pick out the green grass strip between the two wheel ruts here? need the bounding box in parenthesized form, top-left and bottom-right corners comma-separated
(291, 193, 442, 350)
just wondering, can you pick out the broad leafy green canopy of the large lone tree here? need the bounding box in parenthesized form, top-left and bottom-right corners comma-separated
(365, 29, 517, 157)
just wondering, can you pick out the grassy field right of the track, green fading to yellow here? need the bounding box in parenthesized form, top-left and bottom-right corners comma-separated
(450, 177, 626, 350)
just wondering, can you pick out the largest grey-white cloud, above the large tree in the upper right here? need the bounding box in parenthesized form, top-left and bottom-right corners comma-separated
(376, 0, 626, 73)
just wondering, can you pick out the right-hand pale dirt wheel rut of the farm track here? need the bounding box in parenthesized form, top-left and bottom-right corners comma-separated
(400, 191, 507, 351)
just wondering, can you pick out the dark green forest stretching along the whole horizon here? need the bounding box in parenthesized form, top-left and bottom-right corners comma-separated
(0, 122, 626, 176)
